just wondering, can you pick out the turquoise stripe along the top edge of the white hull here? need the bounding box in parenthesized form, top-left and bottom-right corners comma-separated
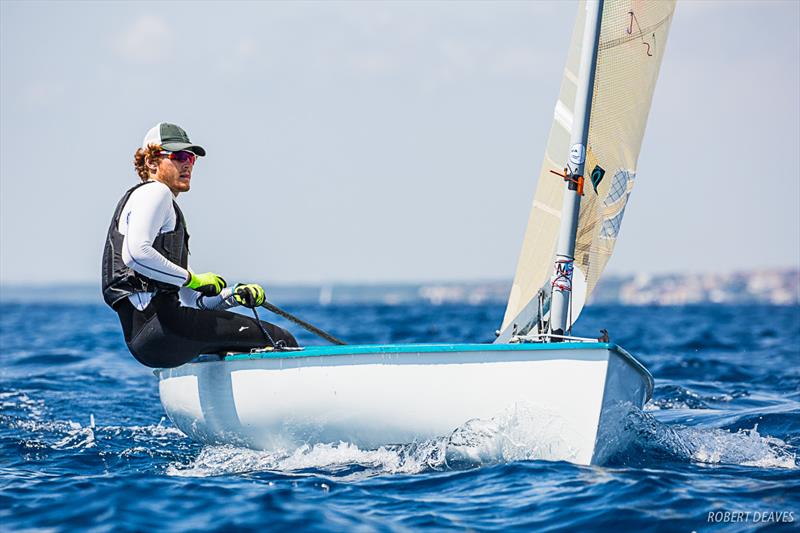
(225, 342, 624, 361)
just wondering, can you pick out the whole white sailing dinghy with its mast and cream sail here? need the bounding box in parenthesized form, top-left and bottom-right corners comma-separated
(156, 0, 674, 464)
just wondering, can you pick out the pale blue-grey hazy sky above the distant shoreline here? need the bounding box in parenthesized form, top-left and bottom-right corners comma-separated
(0, 0, 800, 283)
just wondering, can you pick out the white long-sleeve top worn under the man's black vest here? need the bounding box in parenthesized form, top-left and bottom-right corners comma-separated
(117, 180, 235, 311)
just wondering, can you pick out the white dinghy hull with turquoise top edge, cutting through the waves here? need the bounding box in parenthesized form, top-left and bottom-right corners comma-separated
(156, 343, 653, 464)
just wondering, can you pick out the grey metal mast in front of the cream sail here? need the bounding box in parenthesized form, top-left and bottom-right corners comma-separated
(550, 0, 604, 335)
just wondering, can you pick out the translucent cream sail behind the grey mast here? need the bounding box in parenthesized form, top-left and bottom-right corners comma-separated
(501, 0, 675, 330)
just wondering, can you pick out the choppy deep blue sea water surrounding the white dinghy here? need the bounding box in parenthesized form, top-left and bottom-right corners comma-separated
(0, 303, 800, 531)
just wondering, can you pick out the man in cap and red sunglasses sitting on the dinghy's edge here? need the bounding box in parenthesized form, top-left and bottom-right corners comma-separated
(103, 122, 297, 368)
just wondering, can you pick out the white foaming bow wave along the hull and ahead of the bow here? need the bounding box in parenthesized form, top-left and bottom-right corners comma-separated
(166, 406, 798, 479)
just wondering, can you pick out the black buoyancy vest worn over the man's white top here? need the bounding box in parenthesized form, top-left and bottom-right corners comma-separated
(103, 182, 189, 308)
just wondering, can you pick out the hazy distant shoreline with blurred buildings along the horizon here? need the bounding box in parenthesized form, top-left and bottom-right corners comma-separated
(0, 268, 800, 305)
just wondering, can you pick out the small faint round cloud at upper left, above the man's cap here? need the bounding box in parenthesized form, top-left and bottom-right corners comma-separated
(114, 15, 172, 64)
